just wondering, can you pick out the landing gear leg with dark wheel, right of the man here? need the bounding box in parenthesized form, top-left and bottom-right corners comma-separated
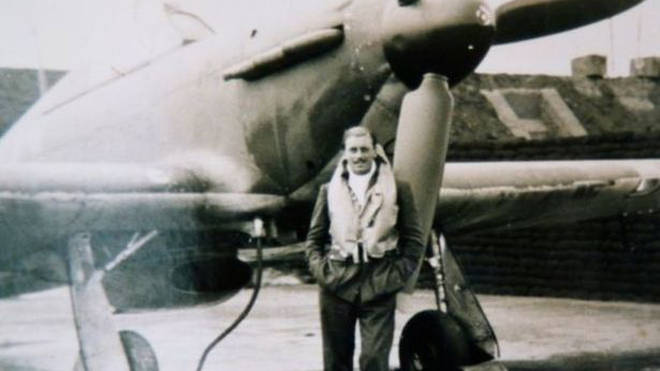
(399, 235, 499, 371)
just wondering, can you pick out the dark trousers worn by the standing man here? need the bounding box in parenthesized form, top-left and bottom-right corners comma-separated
(319, 289, 396, 371)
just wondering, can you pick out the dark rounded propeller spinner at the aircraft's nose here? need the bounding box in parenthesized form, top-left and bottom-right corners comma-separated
(381, 0, 495, 88)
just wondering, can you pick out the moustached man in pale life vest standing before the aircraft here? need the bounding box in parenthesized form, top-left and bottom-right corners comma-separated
(306, 126, 424, 371)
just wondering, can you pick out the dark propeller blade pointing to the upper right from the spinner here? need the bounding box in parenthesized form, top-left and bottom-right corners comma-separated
(495, 0, 644, 44)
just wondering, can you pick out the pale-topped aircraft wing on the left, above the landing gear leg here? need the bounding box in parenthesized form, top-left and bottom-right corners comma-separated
(0, 163, 284, 232)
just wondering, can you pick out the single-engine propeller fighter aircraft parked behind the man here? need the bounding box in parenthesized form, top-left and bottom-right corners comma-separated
(0, 0, 660, 371)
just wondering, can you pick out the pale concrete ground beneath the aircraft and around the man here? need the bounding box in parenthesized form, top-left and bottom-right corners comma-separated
(0, 285, 660, 371)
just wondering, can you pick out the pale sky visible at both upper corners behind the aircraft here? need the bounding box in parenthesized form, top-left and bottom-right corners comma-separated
(0, 0, 660, 76)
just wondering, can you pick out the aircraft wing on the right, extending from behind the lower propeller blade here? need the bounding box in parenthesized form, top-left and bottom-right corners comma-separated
(436, 160, 660, 233)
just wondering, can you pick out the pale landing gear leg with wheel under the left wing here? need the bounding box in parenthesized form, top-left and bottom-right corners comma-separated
(67, 233, 158, 371)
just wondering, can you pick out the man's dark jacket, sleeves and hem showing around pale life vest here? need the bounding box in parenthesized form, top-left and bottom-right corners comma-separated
(305, 158, 425, 302)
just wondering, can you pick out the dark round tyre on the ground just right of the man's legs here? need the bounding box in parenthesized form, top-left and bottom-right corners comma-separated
(399, 310, 470, 371)
